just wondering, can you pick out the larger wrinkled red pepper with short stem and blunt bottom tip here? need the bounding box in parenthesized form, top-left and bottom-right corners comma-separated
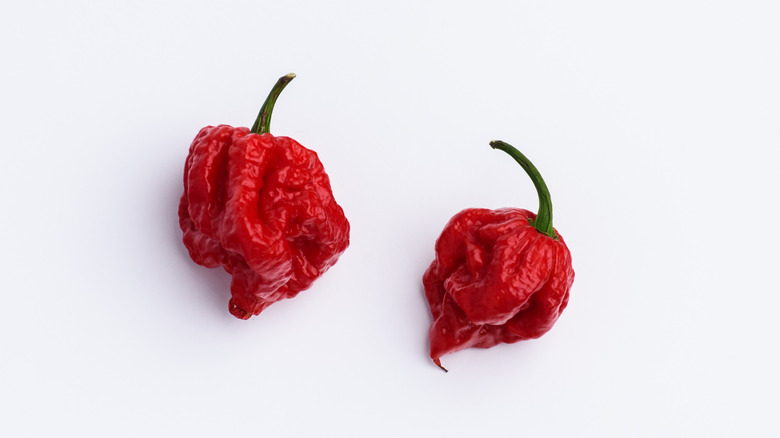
(179, 73, 349, 319)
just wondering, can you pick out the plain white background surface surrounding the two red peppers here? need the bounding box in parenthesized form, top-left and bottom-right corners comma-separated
(0, 0, 780, 437)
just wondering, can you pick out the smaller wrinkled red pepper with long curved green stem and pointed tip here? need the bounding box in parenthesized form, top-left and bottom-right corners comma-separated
(423, 141, 574, 371)
